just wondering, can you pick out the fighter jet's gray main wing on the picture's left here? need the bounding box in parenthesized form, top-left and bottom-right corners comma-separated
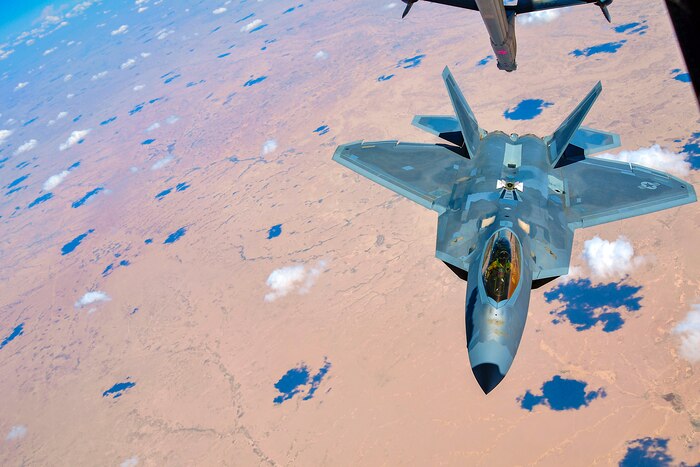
(333, 141, 471, 213)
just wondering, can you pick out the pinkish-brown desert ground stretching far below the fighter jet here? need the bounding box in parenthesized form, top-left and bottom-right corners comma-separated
(0, 0, 700, 466)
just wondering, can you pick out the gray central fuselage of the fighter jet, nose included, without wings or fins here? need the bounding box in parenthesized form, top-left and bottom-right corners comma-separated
(438, 132, 573, 392)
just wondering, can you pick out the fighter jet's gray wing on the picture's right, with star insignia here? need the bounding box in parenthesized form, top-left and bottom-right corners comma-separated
(559, 158, 696, 229)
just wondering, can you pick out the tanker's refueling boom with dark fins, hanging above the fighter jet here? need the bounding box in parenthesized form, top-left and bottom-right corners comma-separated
(401, 0, 612, 71)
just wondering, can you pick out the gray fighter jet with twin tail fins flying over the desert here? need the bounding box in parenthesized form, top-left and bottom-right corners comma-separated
(333, 68, 696, 394)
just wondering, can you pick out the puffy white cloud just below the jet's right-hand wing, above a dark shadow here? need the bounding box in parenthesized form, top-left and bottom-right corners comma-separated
(581, 235, 644, 277)
